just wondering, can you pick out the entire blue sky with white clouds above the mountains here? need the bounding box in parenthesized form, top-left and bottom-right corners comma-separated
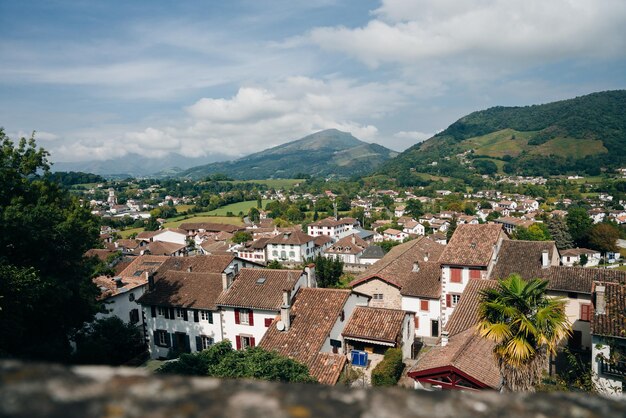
(0, 0, 626, 161)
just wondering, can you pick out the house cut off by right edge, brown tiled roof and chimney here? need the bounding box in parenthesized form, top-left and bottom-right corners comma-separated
(591, 281, 626, 396)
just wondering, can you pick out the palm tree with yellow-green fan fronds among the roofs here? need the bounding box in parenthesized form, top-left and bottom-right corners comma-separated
(477, 274, 571, 391)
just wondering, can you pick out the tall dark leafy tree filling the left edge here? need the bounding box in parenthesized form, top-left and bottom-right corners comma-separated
(0, 129, 99, 361)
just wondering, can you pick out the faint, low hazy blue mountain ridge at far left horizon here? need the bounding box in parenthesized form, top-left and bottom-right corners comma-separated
(52, 153, 226, 177)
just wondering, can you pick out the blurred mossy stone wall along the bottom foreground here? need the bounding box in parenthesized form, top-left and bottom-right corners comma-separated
(0, 361, 626, 418)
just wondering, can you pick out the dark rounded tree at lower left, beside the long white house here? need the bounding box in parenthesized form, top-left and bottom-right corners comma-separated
(73, 316, 146, 366)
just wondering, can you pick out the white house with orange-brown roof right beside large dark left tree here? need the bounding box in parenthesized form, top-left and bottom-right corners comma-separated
(93, 255, 168, 331)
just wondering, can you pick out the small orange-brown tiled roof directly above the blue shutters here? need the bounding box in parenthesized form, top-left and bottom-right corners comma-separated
(341, 306, 407, 343)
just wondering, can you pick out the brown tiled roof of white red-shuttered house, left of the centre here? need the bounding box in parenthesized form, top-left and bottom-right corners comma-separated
(217, 268, 302, 311)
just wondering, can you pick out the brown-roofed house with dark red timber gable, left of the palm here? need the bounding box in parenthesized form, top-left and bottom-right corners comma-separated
(408, 280, 502, 391)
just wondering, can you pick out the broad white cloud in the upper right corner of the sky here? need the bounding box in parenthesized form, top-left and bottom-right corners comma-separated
(309, 0, 626, 67)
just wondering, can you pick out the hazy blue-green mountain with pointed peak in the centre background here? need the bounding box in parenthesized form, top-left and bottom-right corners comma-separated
(179, 129, 397, 180)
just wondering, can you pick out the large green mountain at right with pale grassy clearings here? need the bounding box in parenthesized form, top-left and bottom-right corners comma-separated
(379, 90, 626, 184)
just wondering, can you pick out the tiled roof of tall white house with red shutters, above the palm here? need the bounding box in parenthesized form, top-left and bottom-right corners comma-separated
(439, 224, 504, 266)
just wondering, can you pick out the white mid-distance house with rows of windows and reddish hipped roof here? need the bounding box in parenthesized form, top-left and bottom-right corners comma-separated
(266, 231, 317, 263)
